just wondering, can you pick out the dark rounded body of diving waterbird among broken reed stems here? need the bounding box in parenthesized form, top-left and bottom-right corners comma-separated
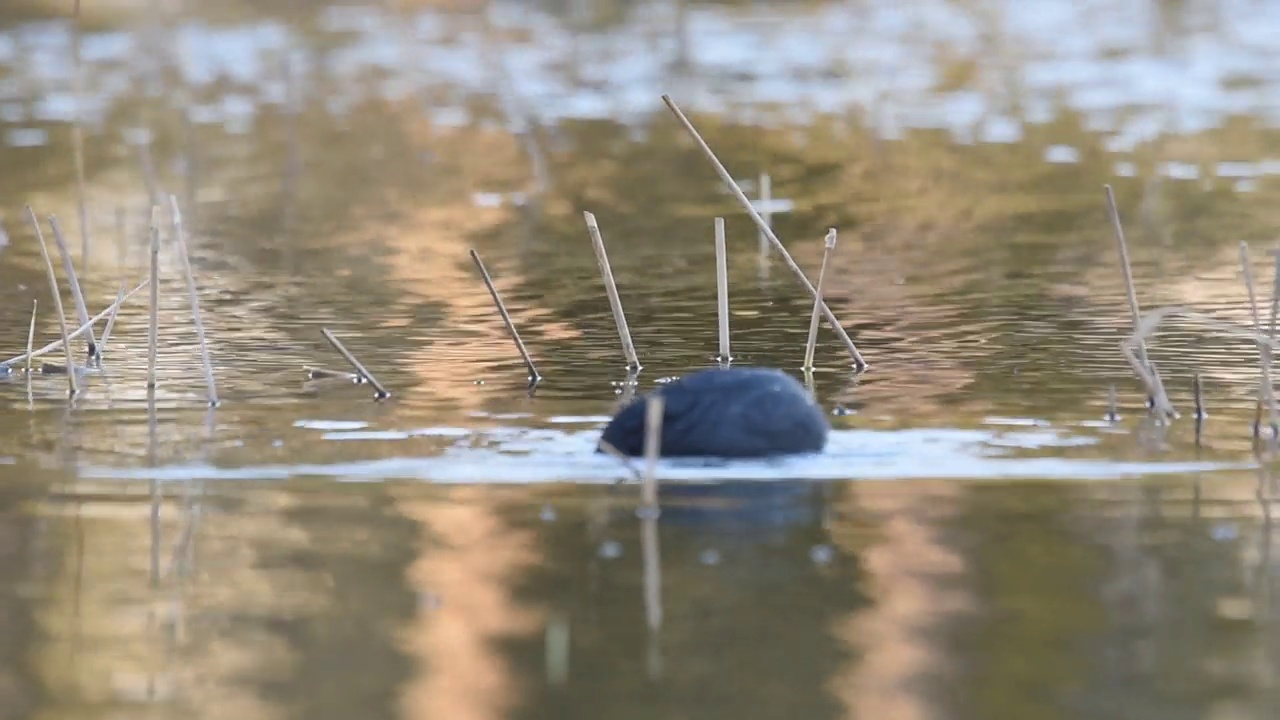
(600, 368, 829, 457)
